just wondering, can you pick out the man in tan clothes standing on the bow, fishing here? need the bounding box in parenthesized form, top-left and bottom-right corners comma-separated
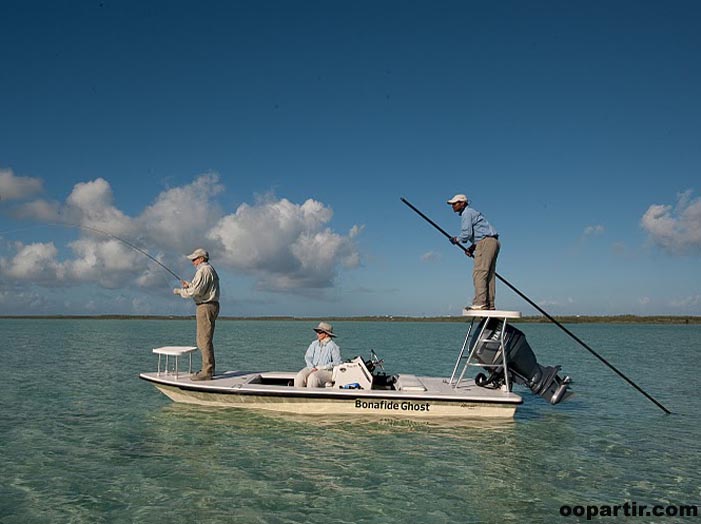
(173, 249, 219, 380)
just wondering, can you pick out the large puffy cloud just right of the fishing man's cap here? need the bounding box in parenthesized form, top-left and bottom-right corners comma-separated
(208, 197, 362, 291)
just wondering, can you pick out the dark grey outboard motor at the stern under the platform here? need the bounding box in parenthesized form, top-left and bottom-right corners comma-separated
(470, 318, 571, 404)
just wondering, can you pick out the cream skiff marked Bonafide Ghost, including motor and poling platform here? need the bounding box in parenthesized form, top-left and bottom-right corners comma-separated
(140, 311, 569, 421)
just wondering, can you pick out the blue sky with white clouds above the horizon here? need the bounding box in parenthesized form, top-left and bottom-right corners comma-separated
(0, 0, 701, 317)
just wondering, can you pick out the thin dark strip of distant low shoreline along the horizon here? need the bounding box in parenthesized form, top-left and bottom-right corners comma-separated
(0, 315, 701, 324)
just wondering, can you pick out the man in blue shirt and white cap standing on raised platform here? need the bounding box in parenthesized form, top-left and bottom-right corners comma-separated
(448, 194, 501, 310)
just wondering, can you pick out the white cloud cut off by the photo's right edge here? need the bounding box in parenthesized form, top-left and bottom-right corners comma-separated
(640, 190, 701, 255)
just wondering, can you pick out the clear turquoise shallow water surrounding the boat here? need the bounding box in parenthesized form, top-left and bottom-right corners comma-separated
(0, 320, 701, 524)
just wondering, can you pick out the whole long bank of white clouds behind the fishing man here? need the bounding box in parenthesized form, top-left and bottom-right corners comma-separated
(0, 173, 363, 292)
